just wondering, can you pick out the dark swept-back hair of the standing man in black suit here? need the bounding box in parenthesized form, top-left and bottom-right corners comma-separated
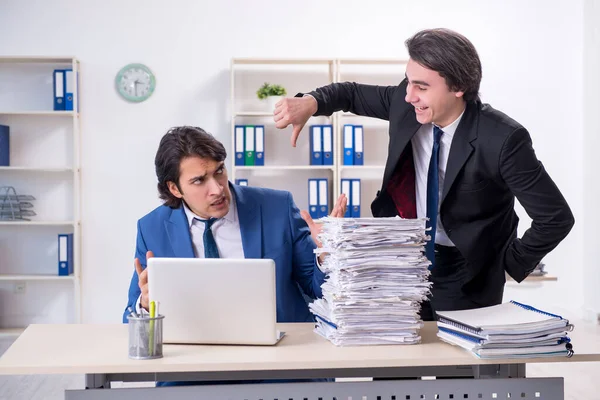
(405, 28, 481, 101)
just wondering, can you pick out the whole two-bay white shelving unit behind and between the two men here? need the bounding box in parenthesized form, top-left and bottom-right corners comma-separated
(229, 58, 406, 217)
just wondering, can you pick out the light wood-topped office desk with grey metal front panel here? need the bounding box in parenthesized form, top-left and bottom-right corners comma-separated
(0, 321, 600, 400)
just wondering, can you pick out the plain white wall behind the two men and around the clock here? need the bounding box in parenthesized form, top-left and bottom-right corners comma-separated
(0, 0, 588, 322)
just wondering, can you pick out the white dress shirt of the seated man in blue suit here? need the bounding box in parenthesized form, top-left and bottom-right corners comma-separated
(135, 192, 244, 314)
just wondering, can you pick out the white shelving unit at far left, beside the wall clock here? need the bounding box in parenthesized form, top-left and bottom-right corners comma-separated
(0, 56, 82, 336)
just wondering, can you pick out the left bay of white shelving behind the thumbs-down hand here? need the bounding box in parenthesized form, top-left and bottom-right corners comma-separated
(229, 58, 337, 209)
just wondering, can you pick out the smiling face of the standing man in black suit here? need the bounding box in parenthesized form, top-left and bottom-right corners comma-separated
(405, 59, 464, 128)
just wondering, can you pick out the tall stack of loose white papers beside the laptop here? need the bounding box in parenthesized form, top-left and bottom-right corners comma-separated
(310, 217, 431, 346)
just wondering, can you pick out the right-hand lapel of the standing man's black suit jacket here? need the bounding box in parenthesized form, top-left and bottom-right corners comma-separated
(440, 102, 479, 204)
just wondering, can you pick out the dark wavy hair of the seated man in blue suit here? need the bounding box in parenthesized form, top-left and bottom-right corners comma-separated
(154, 126, 227, 208)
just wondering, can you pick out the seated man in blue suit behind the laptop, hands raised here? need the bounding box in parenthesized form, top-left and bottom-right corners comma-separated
(123, 126, 346, 323)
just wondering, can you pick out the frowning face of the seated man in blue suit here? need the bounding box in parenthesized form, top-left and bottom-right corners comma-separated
(168, 156, 231, 219)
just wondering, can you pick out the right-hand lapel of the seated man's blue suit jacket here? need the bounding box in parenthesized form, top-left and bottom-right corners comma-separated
(229, 184, 263, 258)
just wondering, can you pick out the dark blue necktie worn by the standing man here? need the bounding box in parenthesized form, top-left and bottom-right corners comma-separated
(425, 125, 444, 270)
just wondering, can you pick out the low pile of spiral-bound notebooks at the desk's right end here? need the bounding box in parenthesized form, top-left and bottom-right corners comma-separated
(437, 301, 573, 359)
